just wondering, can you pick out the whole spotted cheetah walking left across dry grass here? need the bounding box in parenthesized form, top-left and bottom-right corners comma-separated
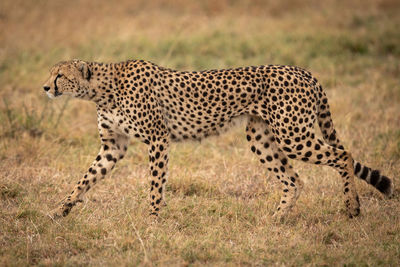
(43, 60, 393, 221)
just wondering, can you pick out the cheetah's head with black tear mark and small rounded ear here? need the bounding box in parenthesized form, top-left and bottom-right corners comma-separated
(43, 60, 91, 98)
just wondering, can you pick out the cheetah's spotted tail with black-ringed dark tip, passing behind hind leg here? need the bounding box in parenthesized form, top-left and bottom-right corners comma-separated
(317, 85, 394, 197)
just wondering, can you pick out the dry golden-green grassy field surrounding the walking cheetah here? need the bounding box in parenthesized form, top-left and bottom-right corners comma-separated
(0, 0, 400, 266)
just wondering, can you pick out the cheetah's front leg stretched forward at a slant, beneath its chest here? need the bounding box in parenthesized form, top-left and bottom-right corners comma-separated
(51, 134, 129, 219)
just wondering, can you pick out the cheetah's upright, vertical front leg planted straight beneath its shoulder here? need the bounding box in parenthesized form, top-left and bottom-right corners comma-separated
(149, 135, 169, 217)
